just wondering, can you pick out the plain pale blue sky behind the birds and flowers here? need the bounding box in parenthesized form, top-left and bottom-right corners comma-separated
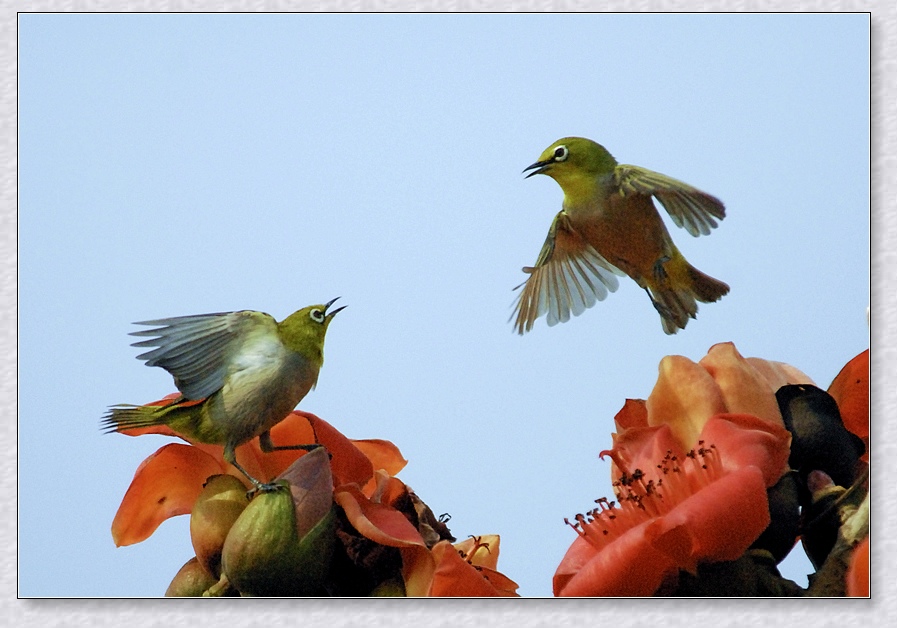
(18, 14, 870, 597)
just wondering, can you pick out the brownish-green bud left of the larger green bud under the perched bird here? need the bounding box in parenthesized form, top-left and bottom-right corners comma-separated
(190, 475, 249, 579)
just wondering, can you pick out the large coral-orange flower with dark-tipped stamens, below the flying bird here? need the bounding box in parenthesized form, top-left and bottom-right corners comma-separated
(554, 343, 809, 596)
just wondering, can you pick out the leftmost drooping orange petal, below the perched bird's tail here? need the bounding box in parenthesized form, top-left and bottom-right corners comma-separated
(112, 443, 225, 547)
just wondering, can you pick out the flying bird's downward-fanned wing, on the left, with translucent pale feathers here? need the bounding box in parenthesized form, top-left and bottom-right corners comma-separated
(512, 211, 623, 334)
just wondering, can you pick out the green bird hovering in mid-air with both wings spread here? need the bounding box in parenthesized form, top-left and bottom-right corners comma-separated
(511, 137, 729, 335)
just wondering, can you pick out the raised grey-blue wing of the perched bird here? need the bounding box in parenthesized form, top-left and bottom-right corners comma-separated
(131, 310, 277, 399)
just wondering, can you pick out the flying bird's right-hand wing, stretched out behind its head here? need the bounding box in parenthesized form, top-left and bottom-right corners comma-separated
(614, 164, 726, 236)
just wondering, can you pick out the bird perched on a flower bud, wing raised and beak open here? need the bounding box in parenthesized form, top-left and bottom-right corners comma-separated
(101, 297, 345, 491)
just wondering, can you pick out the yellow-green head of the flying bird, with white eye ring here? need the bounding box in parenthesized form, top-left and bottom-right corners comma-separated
(524, 137, 617, 197)
